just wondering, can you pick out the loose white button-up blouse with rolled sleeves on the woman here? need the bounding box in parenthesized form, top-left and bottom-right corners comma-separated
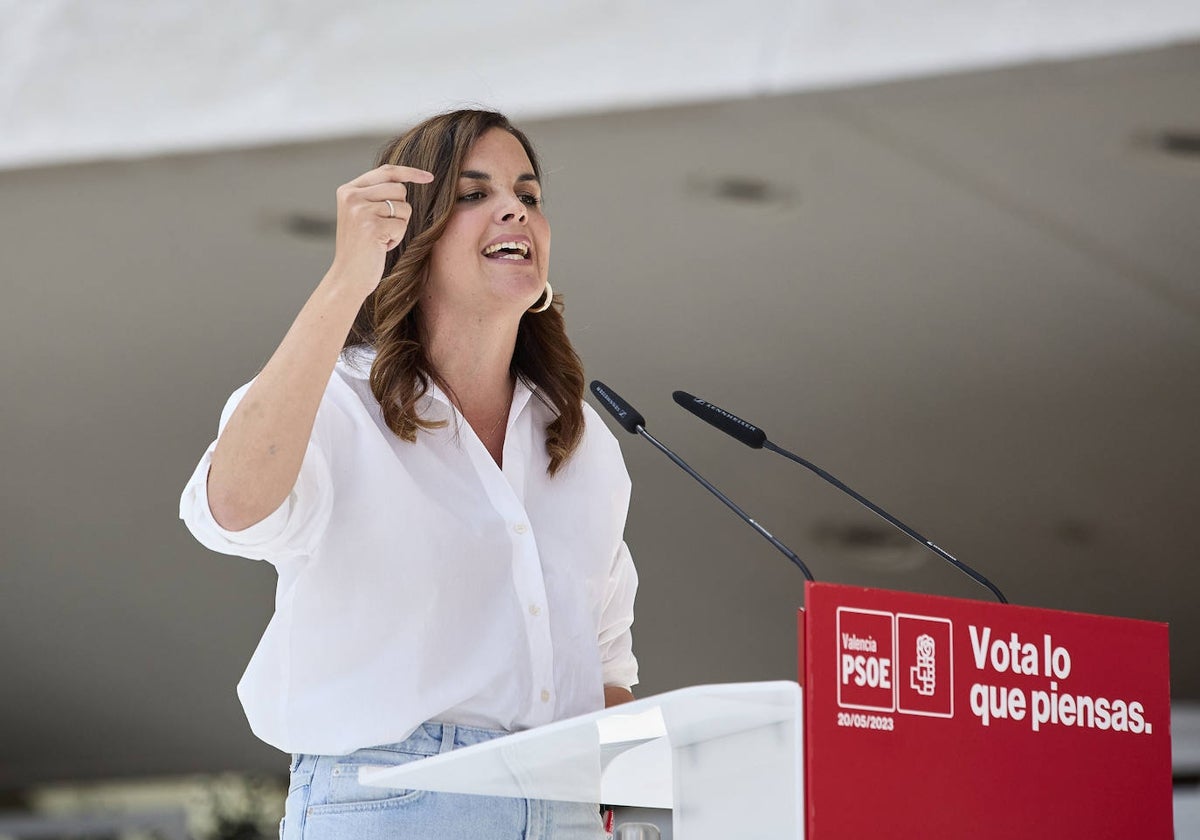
(180, 352, 637, 755)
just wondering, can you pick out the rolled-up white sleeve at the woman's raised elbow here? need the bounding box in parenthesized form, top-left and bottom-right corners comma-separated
(179, 383, 334, 562)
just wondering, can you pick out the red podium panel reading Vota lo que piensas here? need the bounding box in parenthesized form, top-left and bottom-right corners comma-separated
(799, 583, 1172, 840)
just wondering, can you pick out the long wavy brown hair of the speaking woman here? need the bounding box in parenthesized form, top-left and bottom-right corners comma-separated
(343, 110, 584, 475)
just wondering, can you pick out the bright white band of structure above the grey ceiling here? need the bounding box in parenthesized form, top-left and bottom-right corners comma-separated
(0, 0, 1200, 168)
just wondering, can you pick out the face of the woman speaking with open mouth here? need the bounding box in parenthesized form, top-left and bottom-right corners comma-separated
(428, 128, 550, 312)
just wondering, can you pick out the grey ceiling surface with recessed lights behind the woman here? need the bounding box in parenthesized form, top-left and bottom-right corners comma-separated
(0, 39, 1200, 787)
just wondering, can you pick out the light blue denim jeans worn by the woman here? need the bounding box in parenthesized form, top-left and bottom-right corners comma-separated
(280, 724, 606, 840)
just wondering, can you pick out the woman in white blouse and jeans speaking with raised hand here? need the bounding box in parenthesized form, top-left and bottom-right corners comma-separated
(180, 110, 637, 840)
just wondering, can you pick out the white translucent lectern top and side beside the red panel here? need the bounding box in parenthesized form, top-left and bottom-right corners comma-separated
(359, 682, 804, 840)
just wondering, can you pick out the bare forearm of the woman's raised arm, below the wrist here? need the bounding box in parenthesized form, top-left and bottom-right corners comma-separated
(208, 271, 362, 530)
